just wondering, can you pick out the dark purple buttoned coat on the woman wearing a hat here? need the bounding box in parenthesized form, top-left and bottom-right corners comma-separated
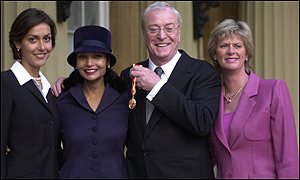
(57, 84, 130, 179)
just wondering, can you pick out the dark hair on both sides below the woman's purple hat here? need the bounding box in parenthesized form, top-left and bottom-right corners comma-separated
(63, 68, 128, 93)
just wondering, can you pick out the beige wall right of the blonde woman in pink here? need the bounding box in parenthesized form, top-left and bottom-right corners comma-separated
(240, 1, 299, 143)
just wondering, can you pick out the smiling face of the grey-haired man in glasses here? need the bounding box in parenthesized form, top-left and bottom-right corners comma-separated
(144, 8, 180, 65)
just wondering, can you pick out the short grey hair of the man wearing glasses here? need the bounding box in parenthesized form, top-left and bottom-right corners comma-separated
(141, 1, 182, 31)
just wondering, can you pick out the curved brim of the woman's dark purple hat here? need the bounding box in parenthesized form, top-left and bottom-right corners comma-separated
(67, 46, 116, 68)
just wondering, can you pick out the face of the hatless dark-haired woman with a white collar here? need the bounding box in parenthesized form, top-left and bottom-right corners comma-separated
(16, 23, 53, 75)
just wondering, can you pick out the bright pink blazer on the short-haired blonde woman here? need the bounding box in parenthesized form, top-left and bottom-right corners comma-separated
(211, 72, 299, 179)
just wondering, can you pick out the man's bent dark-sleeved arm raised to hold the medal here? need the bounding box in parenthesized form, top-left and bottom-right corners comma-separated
(152, 63, 220, 136)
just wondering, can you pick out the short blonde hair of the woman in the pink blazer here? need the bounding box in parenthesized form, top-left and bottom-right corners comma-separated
(208, 19, 254, 73)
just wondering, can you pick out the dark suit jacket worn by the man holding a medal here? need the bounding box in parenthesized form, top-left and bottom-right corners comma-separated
(121, 50, 220, 178)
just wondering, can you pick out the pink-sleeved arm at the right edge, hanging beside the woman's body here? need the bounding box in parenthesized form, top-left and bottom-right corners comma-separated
(271, 80, 299, 179)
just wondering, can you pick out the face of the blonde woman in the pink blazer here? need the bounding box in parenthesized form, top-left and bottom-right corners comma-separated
(215, 35, 248, 71)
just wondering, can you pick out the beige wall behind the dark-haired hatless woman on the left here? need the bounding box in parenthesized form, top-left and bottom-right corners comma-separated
(1, 1, 69, 83)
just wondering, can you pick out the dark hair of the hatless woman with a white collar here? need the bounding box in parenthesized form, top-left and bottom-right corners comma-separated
(9, 8, 56, 59)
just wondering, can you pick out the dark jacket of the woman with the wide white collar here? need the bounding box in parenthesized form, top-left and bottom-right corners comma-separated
(1, 70, 59, 179)
